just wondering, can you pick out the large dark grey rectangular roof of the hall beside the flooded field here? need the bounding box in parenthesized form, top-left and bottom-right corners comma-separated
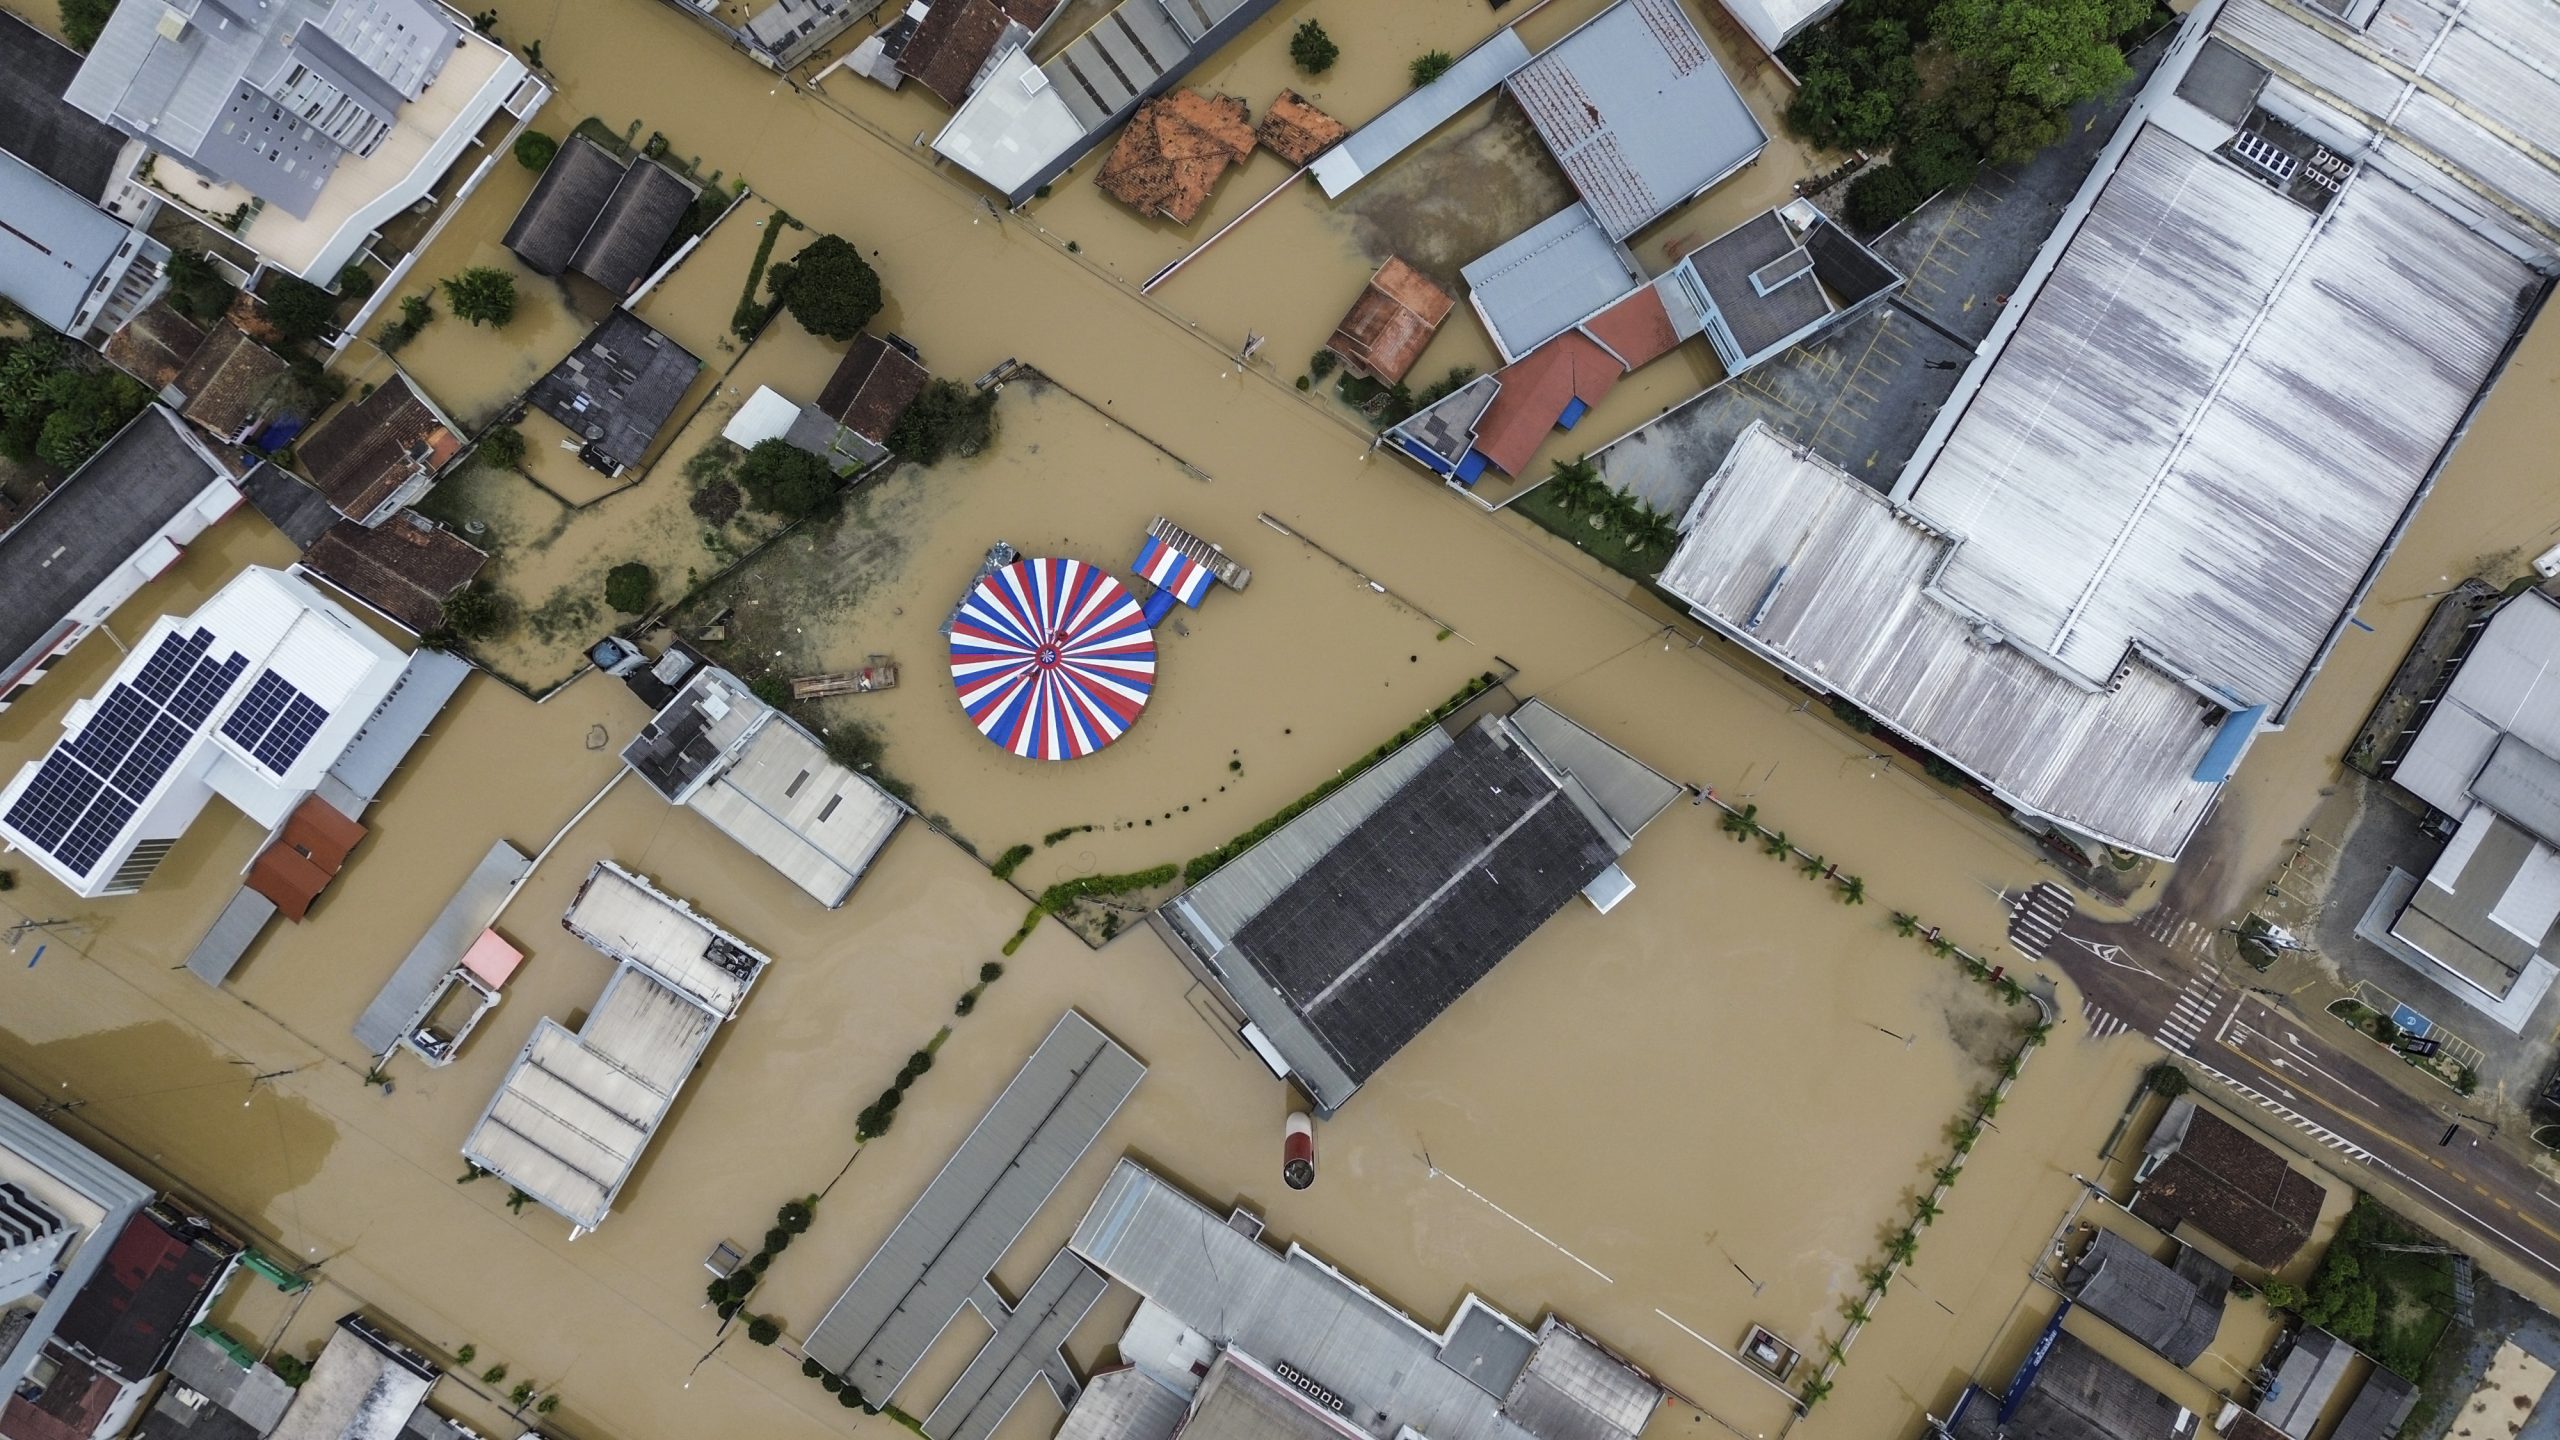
(1234, 725, 1618, 1081)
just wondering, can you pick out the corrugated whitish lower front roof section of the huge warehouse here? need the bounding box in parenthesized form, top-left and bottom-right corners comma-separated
(1661, 423, 2214, 856)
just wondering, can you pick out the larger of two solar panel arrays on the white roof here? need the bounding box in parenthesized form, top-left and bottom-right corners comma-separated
(8, 630, 248, 874)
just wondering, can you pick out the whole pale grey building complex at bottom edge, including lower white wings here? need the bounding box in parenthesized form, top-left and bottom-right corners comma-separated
(1060, 1158, 1664, 1440)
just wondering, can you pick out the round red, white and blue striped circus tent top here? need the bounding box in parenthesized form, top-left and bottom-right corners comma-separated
(952, 559, 1155, 761)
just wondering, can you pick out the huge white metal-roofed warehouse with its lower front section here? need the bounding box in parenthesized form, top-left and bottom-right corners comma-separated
(1664, 0, 2560, 858)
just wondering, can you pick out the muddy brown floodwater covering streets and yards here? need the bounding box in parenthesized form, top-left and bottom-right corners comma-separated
(0, 0, 2560, 1440)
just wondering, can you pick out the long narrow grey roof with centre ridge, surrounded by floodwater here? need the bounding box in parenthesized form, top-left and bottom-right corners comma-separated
(804, 1010, 1147, 1404)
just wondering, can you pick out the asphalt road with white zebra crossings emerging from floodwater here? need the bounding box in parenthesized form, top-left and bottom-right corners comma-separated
(2010, 884, 2560, 1281)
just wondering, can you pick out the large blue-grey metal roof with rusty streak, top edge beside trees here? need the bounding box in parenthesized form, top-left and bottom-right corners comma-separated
(1508, 0, 1769, 241)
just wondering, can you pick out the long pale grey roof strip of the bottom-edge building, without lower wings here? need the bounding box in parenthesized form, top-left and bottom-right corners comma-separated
(1068, 1161, 1661, 1440)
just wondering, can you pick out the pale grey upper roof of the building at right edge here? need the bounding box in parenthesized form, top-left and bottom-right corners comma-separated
(2391, 589, 2560, 817)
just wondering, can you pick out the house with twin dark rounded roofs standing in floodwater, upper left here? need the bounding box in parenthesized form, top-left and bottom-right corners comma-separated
(502, 136, 701, 300)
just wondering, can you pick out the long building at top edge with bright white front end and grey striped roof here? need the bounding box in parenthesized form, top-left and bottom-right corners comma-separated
(936, 0, 1275, 205)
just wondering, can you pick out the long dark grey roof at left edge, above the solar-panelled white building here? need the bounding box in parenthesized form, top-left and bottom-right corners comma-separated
(0, 405, 223, 674)
